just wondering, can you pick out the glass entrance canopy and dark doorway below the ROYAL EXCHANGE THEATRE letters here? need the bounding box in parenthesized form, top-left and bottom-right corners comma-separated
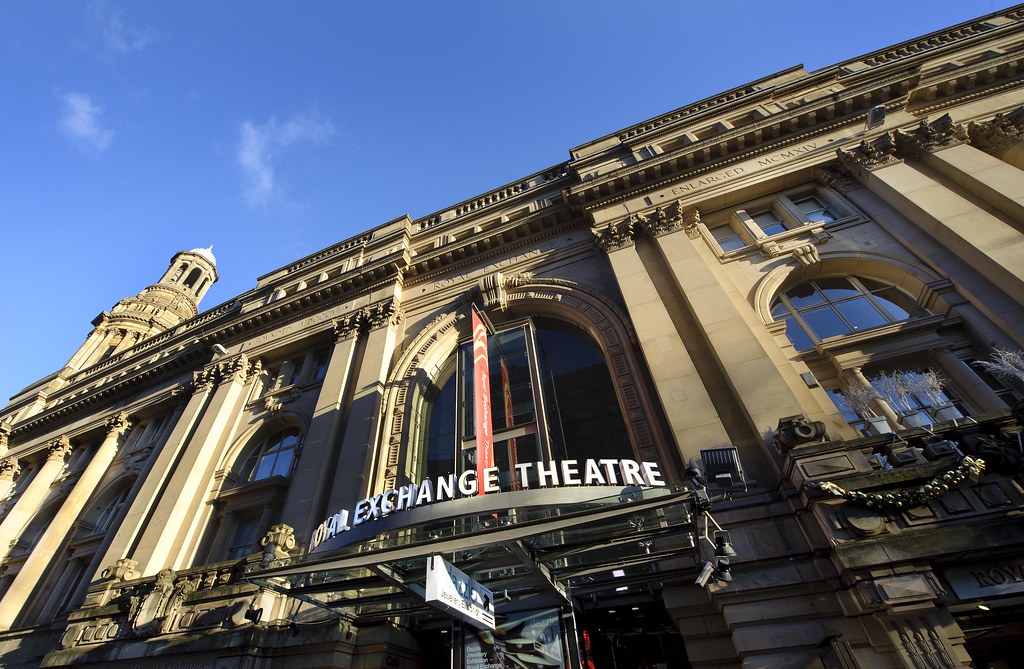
(247, 486, 703, 669)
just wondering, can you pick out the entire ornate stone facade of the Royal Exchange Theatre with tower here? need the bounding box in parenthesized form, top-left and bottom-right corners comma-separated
(0, 6, 1024, 669)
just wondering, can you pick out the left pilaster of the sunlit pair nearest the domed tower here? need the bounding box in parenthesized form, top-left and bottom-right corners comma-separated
(92, 367, 216, 580)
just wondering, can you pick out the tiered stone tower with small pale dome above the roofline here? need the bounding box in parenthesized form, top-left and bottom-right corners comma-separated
(66, 246, 217, 371)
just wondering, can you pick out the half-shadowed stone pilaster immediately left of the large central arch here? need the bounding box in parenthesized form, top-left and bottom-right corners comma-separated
(328, 297, 401, 509)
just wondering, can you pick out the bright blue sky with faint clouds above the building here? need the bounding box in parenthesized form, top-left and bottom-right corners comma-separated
(0, 0, 1009, 404)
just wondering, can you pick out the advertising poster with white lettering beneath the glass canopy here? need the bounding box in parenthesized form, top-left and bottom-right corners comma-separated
(464, 609, 565, 669)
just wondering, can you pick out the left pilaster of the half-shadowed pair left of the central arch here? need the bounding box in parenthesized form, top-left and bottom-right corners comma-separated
(282, 317, 359, 536)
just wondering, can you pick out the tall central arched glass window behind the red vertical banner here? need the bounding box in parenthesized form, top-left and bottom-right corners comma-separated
(410, 320, 634, 490)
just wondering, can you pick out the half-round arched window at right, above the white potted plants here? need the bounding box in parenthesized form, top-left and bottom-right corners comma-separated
(771, 277, 927, 350)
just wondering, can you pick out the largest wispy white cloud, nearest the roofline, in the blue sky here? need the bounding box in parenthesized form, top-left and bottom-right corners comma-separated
(236, 116, 335, 207)
